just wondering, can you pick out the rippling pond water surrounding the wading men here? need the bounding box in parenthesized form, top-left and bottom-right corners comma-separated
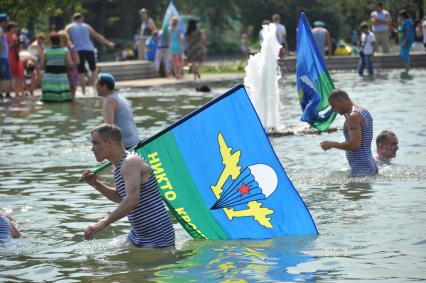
(0, 70, 426, 282)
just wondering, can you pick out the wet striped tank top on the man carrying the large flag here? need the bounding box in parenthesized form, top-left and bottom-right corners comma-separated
(114, 154, 175, 248)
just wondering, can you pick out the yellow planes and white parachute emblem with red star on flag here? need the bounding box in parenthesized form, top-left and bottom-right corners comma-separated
(211, 133, 278, 228)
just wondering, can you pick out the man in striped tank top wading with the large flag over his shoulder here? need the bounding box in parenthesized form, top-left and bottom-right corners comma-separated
(83, 124, 175, 248)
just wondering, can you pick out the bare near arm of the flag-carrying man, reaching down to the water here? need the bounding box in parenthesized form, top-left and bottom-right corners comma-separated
(84, 154, 146, 240)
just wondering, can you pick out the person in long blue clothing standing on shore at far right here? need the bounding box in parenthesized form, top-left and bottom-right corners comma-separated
(398, 10, 414, 72)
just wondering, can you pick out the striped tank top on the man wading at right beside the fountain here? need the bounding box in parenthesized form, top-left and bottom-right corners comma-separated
(343, 106, 377, 177)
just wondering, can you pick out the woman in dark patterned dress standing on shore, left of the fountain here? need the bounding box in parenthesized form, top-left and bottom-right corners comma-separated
(185, 19, 207, 81)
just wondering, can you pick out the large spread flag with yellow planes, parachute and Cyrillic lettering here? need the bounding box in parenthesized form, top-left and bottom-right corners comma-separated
(137, 85, 318, 240)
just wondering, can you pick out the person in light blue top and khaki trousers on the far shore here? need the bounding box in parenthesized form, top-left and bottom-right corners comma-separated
(371, 2, 392, 53)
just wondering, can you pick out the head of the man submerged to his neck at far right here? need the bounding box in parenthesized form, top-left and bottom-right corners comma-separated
(374, 130, 398, 165)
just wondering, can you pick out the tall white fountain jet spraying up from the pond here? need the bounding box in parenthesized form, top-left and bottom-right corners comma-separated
(244, 24, 281, 132)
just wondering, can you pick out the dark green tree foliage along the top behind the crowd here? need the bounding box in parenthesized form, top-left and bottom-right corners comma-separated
(0, 0, 425, 53)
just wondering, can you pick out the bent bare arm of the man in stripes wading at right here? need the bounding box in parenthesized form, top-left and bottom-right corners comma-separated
(321, 112, 362, 151)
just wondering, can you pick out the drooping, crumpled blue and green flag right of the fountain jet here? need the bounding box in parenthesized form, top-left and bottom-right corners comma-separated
(296, 12, 336, 131)
